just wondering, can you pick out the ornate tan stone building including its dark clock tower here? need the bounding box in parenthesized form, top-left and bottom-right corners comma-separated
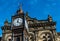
(2, 6, 60, 41)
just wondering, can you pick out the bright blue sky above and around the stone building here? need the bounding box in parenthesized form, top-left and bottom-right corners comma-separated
(0, 0, 60, 36)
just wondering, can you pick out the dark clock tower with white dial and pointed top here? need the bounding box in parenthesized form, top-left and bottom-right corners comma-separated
(11, 6, 27, 41)
